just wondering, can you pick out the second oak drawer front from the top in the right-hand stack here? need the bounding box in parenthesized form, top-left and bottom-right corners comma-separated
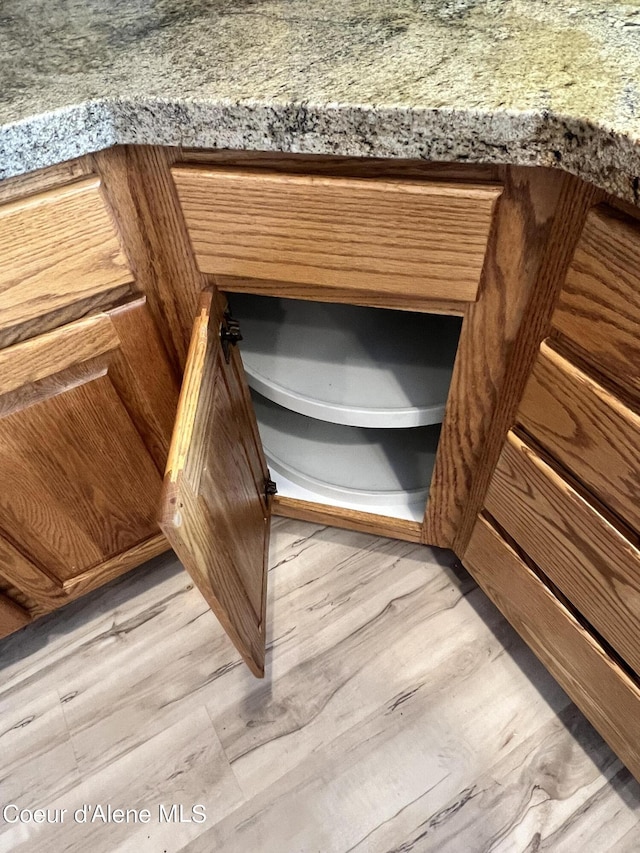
(518, 342, 640, 532)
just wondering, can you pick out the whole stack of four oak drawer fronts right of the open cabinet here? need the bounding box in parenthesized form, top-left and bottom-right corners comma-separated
(465, 208, 640, 774)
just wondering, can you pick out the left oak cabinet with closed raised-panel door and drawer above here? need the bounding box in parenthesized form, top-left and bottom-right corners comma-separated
(0, 170, 178, 620)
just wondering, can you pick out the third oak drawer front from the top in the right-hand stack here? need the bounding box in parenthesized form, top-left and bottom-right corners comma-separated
(485, 433, 640, 673)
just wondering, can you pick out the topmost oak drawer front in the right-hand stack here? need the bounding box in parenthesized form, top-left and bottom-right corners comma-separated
(552, 207, 640, 391)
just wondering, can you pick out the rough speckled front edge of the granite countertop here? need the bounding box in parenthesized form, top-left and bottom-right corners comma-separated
(0, 98, 640, 205)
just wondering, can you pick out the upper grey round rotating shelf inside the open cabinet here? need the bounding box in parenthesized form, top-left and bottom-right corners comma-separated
(231, 294, 462, 429)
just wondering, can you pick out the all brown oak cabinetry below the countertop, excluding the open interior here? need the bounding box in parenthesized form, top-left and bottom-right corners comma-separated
(0, 147, 640, 774)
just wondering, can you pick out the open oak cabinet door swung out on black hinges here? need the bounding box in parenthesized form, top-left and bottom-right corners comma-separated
(160, 293, 270, 678)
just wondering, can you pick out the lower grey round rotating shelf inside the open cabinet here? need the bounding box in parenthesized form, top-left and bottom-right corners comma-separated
(252, 392, 440, 517)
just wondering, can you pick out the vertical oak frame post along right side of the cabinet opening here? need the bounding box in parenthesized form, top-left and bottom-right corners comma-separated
(423, 168, 562, 550)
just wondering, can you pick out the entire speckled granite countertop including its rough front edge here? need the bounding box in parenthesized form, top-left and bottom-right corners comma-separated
(0, 0, 640, 203)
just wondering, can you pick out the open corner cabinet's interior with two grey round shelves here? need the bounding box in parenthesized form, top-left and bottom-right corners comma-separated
(229, 293, 462, 522)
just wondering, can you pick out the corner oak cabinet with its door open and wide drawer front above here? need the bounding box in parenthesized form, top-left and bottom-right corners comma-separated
(155, 158, 580, 676)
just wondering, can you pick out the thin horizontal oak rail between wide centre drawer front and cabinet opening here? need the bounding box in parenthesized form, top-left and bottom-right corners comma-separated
(213, 275, 465, 317)
